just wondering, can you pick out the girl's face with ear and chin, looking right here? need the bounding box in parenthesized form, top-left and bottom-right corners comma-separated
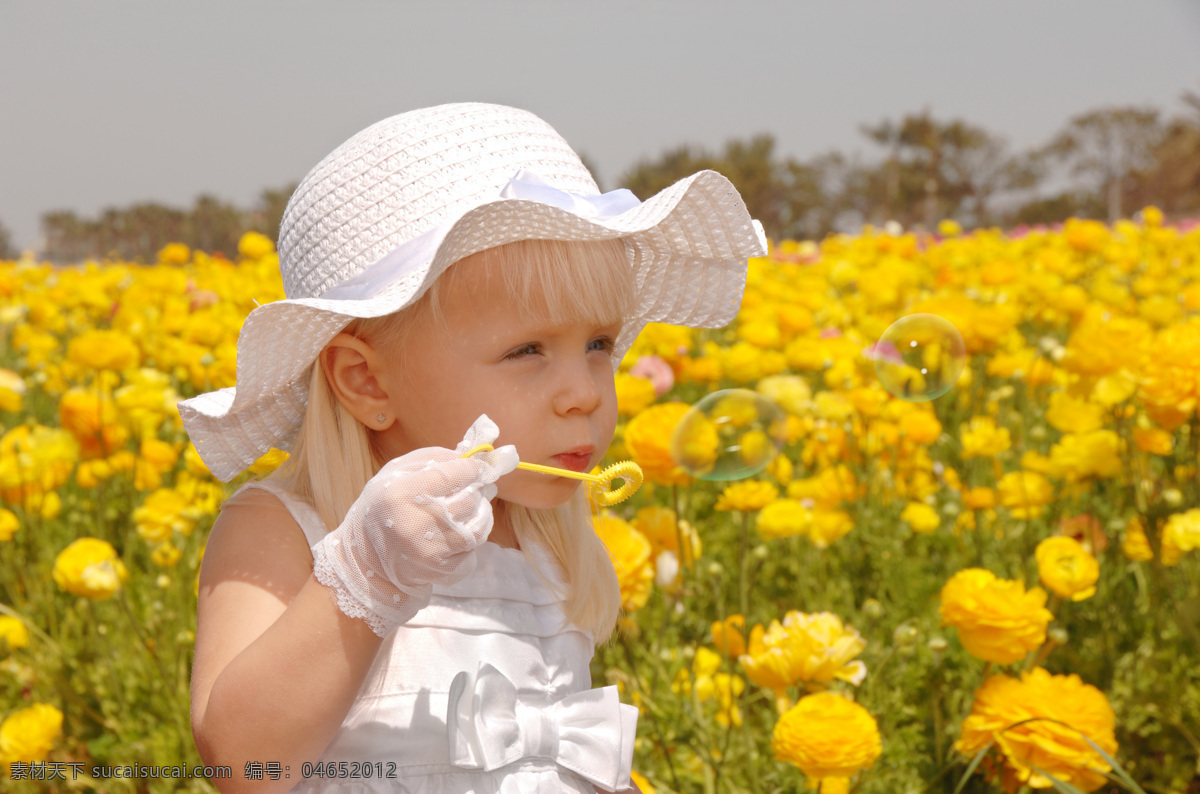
(377, 254, 622, 509)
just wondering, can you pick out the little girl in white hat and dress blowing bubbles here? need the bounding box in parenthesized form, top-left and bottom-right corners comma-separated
(180, 103, 764, 794)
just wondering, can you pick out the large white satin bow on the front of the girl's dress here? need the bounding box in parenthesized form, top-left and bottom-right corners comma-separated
(446, 663, 637, 792)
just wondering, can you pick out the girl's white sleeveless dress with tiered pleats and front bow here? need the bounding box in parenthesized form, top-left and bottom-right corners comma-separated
(230, 480, 637, 794)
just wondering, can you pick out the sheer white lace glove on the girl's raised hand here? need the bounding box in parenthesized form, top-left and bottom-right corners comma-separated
(312, 414, 518, 637)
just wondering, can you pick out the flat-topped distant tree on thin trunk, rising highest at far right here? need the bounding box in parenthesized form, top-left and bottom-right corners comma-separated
(1042, 107, 1164, 223)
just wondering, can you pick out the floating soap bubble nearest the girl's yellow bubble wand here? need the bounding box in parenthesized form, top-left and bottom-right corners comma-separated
(671, 389, 787, 480)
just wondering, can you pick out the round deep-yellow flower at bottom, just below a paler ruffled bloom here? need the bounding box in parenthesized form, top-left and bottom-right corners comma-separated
(770, 692, 883, 780)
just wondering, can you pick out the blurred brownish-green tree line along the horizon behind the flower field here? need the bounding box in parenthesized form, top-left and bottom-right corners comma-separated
(0, 91, 1200, 263)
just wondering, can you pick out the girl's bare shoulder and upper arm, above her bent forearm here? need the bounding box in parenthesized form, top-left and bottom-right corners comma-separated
(192, 488, 312, 716)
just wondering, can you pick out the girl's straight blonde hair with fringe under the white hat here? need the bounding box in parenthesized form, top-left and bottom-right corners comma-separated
(271, 240, 635, 644)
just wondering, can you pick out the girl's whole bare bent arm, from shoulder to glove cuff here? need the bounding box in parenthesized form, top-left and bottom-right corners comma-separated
(192, 494, 383, 793)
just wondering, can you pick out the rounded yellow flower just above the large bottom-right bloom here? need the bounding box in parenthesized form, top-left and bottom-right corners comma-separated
(938, 569, 1054, 664)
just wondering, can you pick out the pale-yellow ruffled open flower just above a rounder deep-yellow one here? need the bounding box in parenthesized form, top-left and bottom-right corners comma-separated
(738, 610, 866, 696)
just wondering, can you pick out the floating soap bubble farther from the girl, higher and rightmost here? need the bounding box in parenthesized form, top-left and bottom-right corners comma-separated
(863, 314, 966, 403)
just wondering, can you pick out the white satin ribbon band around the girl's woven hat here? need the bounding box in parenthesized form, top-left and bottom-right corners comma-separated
(320, 168, 642, 301)
